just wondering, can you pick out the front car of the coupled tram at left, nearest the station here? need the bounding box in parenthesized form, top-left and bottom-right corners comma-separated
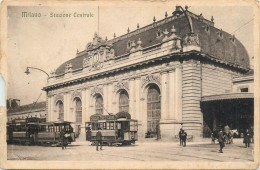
(36, 121, 75, 146)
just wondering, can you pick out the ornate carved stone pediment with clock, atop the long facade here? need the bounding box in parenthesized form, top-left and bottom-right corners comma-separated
(83, 34, 115, 71)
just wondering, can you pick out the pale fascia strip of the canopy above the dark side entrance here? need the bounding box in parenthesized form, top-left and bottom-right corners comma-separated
(201, 93, 254, 102)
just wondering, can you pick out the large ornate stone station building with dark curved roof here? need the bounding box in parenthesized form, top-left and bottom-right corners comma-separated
(43, 7, 253, 140)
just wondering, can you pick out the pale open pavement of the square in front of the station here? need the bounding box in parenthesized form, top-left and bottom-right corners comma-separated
(7, 139, 254, 162)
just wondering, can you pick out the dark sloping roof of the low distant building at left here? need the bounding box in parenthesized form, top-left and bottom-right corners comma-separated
(7, 101, 46, 114)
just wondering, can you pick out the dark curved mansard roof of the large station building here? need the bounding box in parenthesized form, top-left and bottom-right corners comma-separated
(55, 7, 249, 75)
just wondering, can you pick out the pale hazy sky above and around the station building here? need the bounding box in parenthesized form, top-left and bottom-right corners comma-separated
(7, 4, 254, 105)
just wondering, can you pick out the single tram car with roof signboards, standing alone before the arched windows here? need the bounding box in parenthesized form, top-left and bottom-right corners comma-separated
(85, 112, 138, 146)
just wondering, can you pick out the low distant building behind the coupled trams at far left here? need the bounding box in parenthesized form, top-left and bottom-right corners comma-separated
(7, 101, 47, 122)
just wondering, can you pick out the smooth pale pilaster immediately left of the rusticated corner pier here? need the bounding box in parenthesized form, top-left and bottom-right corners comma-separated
(167, 70, 176, 119)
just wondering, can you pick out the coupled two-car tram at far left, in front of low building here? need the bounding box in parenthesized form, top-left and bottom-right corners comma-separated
(7, 118, 75, 146)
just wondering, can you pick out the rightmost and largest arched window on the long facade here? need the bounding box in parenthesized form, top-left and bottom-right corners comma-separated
(147, 85, 161, 133)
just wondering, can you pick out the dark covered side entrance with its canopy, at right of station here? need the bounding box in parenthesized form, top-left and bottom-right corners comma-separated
(201, 93, 254, 137)
